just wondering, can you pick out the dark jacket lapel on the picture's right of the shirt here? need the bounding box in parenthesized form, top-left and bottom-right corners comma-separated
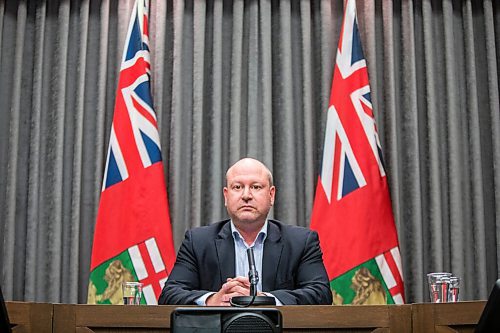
(261, 220, 283, 291)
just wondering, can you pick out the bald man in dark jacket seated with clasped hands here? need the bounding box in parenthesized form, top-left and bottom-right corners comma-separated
(158, 158, 332, 306)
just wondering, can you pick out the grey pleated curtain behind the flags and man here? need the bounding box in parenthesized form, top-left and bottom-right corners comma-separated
(0, 0, 500, 303)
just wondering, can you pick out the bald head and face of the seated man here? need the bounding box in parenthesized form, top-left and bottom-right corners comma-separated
(224, 160, 276, 224)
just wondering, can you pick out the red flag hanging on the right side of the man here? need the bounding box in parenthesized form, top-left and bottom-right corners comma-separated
(311, 0, 404, 304)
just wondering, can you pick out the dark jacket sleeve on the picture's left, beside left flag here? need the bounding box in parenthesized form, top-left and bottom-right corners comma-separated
(158, 231, 209, 305)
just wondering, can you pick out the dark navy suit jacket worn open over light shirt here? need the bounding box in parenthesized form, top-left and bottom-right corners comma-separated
(158, 220, 332, 305)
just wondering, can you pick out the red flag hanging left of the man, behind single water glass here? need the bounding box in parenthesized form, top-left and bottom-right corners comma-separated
(88, 0, 175, 304)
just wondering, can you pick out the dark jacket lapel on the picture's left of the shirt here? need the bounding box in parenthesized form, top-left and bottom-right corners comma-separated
(215, 222, 236, 288)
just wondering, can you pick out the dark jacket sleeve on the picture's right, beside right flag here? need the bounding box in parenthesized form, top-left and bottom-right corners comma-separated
(270, 230, 332, 305)
